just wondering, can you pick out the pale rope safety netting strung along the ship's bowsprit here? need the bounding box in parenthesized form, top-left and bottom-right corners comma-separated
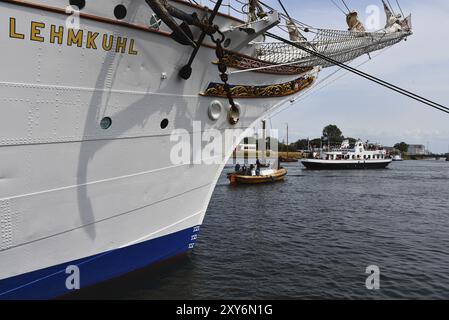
(181, 0, 411, 68)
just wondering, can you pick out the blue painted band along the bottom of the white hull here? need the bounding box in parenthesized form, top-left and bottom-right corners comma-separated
(0, 227, 199, 300)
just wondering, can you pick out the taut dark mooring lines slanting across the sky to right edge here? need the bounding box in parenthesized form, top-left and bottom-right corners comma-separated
(266, 32, 449, 114)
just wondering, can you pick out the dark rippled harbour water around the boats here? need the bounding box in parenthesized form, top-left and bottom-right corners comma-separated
(75, 161, 449, 299)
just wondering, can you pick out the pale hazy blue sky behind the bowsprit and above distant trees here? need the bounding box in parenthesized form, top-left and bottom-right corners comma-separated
(265, 0, 449, 153)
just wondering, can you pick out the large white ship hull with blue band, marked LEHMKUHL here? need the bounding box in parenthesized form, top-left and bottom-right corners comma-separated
(0, 0, 316, 299)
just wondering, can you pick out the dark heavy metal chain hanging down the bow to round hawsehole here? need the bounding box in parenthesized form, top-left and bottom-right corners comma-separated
(210, 30, 240, 125)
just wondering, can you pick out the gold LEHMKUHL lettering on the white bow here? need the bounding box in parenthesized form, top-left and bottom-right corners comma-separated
(9, 17, 139, 55)
